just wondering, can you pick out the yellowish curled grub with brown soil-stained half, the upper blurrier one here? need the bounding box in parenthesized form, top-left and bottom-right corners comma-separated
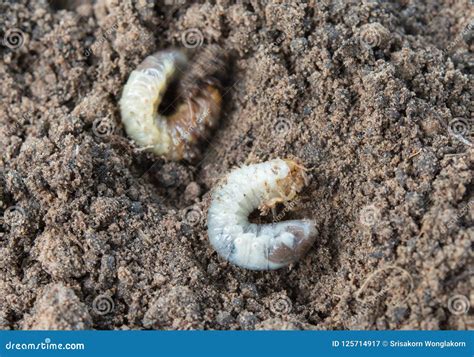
(120, 50, 222, 160)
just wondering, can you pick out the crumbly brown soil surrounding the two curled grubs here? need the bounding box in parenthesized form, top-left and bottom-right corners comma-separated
(0, 0, 474, 329)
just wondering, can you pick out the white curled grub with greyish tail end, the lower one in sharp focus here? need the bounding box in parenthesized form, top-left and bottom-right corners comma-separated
(207, 159, 317, 270)
